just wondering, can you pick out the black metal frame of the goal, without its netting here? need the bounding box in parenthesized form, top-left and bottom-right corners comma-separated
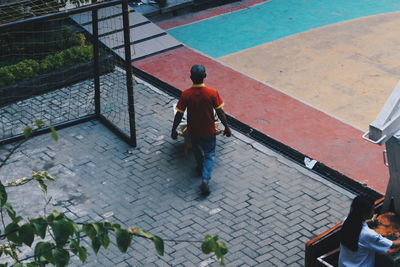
(0, 0, 137, 147)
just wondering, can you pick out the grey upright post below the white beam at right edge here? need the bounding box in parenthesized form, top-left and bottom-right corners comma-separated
(382, 135, 400, 214)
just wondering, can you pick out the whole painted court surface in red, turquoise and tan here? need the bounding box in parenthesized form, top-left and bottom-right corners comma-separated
(134, 0, 400, 194)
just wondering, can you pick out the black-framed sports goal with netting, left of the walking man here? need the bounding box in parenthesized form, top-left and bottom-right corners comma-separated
(0, 0, 136, 146)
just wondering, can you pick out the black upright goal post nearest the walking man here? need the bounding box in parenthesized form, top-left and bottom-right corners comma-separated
(122, 0, 136, 147)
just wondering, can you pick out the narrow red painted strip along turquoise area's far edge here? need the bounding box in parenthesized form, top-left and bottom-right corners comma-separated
(157, 0, 269, 30)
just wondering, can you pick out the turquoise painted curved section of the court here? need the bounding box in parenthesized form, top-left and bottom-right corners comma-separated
(168, 0, 400, 58)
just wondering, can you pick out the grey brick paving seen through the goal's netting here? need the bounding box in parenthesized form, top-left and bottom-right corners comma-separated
(0, 67, 129, 141)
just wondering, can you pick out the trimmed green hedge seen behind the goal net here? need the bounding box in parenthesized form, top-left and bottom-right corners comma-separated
(0, 45, 93, 87)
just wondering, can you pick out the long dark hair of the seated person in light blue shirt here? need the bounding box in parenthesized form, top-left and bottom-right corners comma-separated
(340, 196, 374, 251)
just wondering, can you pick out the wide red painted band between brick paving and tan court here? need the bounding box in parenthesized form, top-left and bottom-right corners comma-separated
(133, 47, 389, 194)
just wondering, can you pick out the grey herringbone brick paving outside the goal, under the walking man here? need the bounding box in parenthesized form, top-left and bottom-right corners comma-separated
(0, 79, 352, 267)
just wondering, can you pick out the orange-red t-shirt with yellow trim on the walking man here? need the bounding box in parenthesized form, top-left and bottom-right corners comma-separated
(176, 84, 224, 137)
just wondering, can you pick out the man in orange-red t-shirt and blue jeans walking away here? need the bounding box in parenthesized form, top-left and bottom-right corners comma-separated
(171, 65, 232, 196)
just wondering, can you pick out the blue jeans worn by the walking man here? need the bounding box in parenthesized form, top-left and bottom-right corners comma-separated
(190, 135, 216, 183)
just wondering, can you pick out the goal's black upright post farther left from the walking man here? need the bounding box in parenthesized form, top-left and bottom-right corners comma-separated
(92, 0, 100, 116)
